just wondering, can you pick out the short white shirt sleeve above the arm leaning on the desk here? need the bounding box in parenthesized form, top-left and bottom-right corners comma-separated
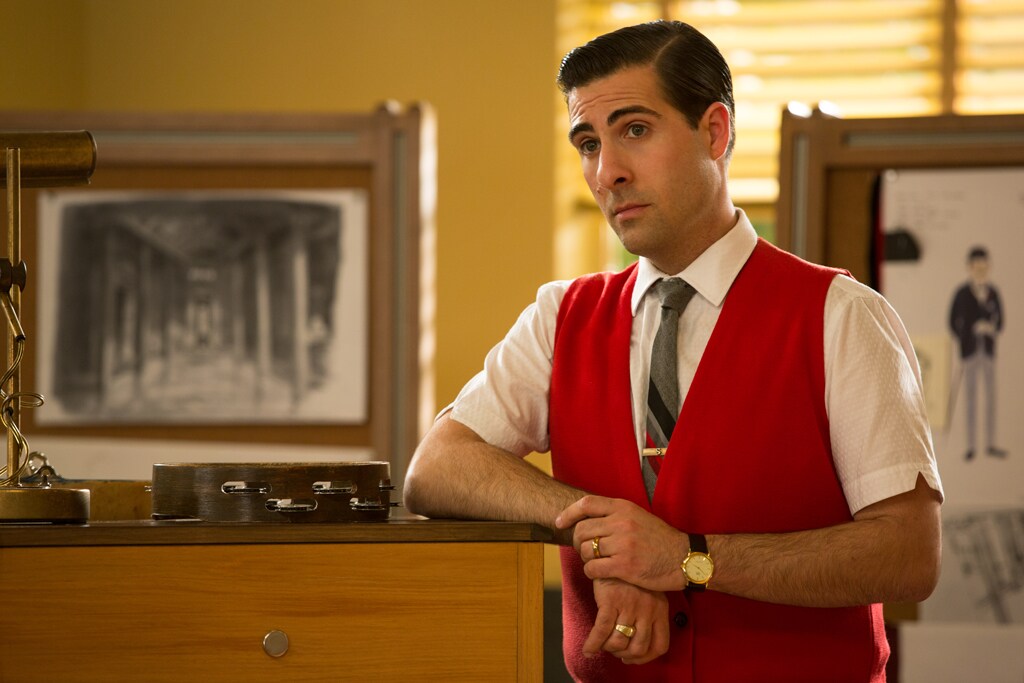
(451, 281, 569, 457)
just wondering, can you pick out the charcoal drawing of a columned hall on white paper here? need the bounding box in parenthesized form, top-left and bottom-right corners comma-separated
(37, 185, 369, 425)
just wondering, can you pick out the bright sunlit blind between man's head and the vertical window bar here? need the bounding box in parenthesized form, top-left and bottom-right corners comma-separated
(669, 0, 943, 203)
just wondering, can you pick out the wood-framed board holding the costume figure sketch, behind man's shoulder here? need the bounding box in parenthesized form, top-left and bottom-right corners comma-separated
(777, 111, 1024, 680)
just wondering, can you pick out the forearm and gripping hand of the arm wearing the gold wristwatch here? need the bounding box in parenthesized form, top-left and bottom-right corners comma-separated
(558, 477, 941, 607)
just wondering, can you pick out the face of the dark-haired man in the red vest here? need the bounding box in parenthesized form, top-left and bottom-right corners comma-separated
(568, 66, 728, 273)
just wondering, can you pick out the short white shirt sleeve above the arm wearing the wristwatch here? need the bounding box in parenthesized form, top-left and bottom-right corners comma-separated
(824, 275, 942, 514)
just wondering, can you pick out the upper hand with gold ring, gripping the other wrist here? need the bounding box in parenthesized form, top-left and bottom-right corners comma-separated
(555, 496, 689, 591)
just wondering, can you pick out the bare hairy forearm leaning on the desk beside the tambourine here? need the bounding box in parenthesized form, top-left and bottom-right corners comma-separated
(404, 415, 584, 544)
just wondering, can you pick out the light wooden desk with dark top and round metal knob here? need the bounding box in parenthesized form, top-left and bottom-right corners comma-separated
(0, 520, 548, 683)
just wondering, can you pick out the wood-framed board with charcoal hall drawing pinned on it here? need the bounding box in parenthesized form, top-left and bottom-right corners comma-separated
(0, 104, 436, 481)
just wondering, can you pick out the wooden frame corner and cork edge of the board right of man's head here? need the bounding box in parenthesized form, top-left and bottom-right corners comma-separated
(776, 109, 1024, 286)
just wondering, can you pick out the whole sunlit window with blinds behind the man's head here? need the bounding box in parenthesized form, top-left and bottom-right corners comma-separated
(556, 0, 1024, 276)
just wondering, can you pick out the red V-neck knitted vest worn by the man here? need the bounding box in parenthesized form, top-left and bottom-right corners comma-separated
(550, 241, 889, 683)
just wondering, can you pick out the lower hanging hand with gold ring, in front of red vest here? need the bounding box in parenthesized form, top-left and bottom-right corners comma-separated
(583, 579, 669, 664)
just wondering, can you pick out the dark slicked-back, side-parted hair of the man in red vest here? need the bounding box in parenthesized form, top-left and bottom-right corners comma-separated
(558, 22, 736, 154)
